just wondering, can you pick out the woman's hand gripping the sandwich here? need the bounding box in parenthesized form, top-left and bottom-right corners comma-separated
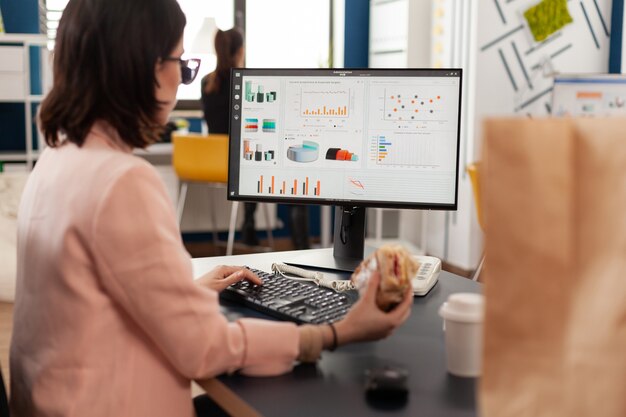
(335, 271, 413, 345)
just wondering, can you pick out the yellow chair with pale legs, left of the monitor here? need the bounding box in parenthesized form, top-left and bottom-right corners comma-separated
(172, 133, 274, 255)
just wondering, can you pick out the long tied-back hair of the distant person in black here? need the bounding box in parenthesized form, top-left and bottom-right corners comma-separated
(205, 28, 243, 94)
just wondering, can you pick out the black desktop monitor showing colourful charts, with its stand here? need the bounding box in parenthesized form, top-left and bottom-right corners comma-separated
(228, 69, 462, 270)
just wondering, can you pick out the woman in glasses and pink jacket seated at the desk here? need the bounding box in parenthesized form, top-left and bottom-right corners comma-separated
(11, 0, 411, 417)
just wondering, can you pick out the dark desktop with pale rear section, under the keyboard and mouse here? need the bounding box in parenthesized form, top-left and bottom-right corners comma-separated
(193, 249, 480, 417)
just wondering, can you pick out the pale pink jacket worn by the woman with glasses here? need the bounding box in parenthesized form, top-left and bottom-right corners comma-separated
(11, 124, 299, 417)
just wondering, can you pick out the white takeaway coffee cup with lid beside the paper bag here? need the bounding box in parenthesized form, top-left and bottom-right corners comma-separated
(439, 293, 484, 377)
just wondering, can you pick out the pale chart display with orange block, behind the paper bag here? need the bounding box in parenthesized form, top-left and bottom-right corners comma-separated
(552, 74, 626, 117)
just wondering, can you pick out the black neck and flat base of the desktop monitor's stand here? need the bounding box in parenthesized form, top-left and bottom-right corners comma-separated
(287, 206, 369, 273)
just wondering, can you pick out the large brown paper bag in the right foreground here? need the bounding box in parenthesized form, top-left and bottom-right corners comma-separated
(480, 119, 626, 417)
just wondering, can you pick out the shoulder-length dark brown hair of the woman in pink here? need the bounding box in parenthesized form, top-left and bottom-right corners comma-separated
(39, 0, 186, 148)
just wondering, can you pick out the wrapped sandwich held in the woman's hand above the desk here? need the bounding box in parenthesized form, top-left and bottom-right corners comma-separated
(352, 245, 419, 311)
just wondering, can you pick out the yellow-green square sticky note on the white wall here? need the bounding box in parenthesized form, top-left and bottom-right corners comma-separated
(524, 0, 574, 42)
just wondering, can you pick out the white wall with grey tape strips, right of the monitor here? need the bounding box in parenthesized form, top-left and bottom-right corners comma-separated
(428, 0, 612, 269)
